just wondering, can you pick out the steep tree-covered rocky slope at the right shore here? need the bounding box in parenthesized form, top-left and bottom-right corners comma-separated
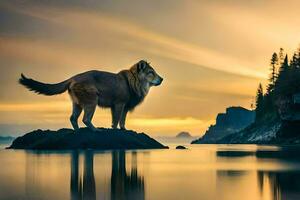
(193, 48, 300, 144)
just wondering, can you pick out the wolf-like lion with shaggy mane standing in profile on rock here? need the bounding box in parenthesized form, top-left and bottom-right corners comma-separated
(19, 60, 163, 131)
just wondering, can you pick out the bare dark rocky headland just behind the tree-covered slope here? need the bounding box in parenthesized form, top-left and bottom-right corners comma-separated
(192, 107, 255, 144)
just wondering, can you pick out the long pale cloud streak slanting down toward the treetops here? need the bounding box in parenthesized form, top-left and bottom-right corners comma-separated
(0, 3, 265, 78)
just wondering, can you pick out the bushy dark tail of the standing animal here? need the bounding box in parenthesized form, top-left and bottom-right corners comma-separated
(19, 74, 70, 96)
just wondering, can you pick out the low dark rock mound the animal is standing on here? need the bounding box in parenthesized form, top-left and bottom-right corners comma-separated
(9, 128, 168, 150)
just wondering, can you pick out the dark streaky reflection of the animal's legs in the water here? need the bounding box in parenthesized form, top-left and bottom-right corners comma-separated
(70, 151, 145, 200)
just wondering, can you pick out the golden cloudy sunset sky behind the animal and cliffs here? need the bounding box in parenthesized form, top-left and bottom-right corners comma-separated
(0, 0, 300, 136)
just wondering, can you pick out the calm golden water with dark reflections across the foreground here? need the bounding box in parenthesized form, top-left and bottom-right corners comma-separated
(0, 142, 300, 200)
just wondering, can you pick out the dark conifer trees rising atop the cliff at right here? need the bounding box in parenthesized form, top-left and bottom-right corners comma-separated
(255, 47, 300, 122)
